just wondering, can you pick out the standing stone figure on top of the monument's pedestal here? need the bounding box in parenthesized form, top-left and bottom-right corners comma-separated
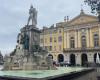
(27, 5, 37, 25)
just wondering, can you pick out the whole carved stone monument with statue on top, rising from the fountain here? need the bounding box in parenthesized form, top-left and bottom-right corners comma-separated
(4, 6, 56, 70)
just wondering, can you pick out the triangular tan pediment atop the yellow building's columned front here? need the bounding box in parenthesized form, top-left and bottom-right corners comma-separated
(69, 13, 98, 25)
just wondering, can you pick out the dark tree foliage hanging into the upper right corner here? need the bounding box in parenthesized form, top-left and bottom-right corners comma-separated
(84, 0, 100, 22)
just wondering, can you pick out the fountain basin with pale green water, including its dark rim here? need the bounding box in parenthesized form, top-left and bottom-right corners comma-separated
(0, 67, 94, 80)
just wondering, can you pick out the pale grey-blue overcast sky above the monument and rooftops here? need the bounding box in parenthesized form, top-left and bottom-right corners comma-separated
(0, 0, 93, 55)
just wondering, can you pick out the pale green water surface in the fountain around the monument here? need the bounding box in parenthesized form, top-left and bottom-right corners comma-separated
(0, 67, 85, 78)
